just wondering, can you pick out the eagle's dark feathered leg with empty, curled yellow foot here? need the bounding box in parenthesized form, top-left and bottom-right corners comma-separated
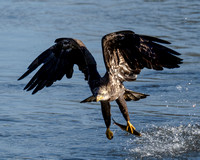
(101, 101, 113, 140)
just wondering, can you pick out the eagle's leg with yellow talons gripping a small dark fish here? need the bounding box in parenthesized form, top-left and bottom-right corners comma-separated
(114, 96, 141, 136)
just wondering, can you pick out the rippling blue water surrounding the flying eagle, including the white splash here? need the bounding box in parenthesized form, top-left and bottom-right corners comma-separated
(0, 0, 200, 160)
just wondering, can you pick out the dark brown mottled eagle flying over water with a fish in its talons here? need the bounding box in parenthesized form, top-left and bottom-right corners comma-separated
(18, 30, 182, 140)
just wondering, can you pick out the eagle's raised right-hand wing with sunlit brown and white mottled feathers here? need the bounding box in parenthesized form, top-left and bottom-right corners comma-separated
(102, 31, 182, 81)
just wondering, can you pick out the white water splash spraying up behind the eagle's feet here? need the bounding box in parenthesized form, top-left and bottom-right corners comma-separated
(127, 124, 200, 158)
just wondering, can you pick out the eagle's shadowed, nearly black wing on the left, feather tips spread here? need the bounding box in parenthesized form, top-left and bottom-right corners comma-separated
(18, 38, 96, 94)
